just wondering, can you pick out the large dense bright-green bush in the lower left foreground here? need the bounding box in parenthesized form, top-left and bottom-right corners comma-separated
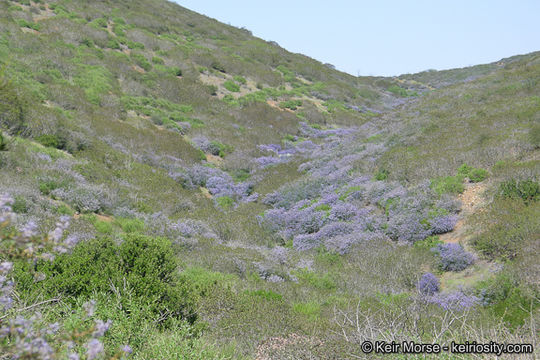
(18, 234, 193, 322)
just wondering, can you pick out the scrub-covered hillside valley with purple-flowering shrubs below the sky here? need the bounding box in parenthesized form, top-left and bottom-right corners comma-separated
(0, 0, 540, 359)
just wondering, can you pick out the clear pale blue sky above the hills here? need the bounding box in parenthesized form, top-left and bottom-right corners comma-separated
(174, 0, 540, 76)
